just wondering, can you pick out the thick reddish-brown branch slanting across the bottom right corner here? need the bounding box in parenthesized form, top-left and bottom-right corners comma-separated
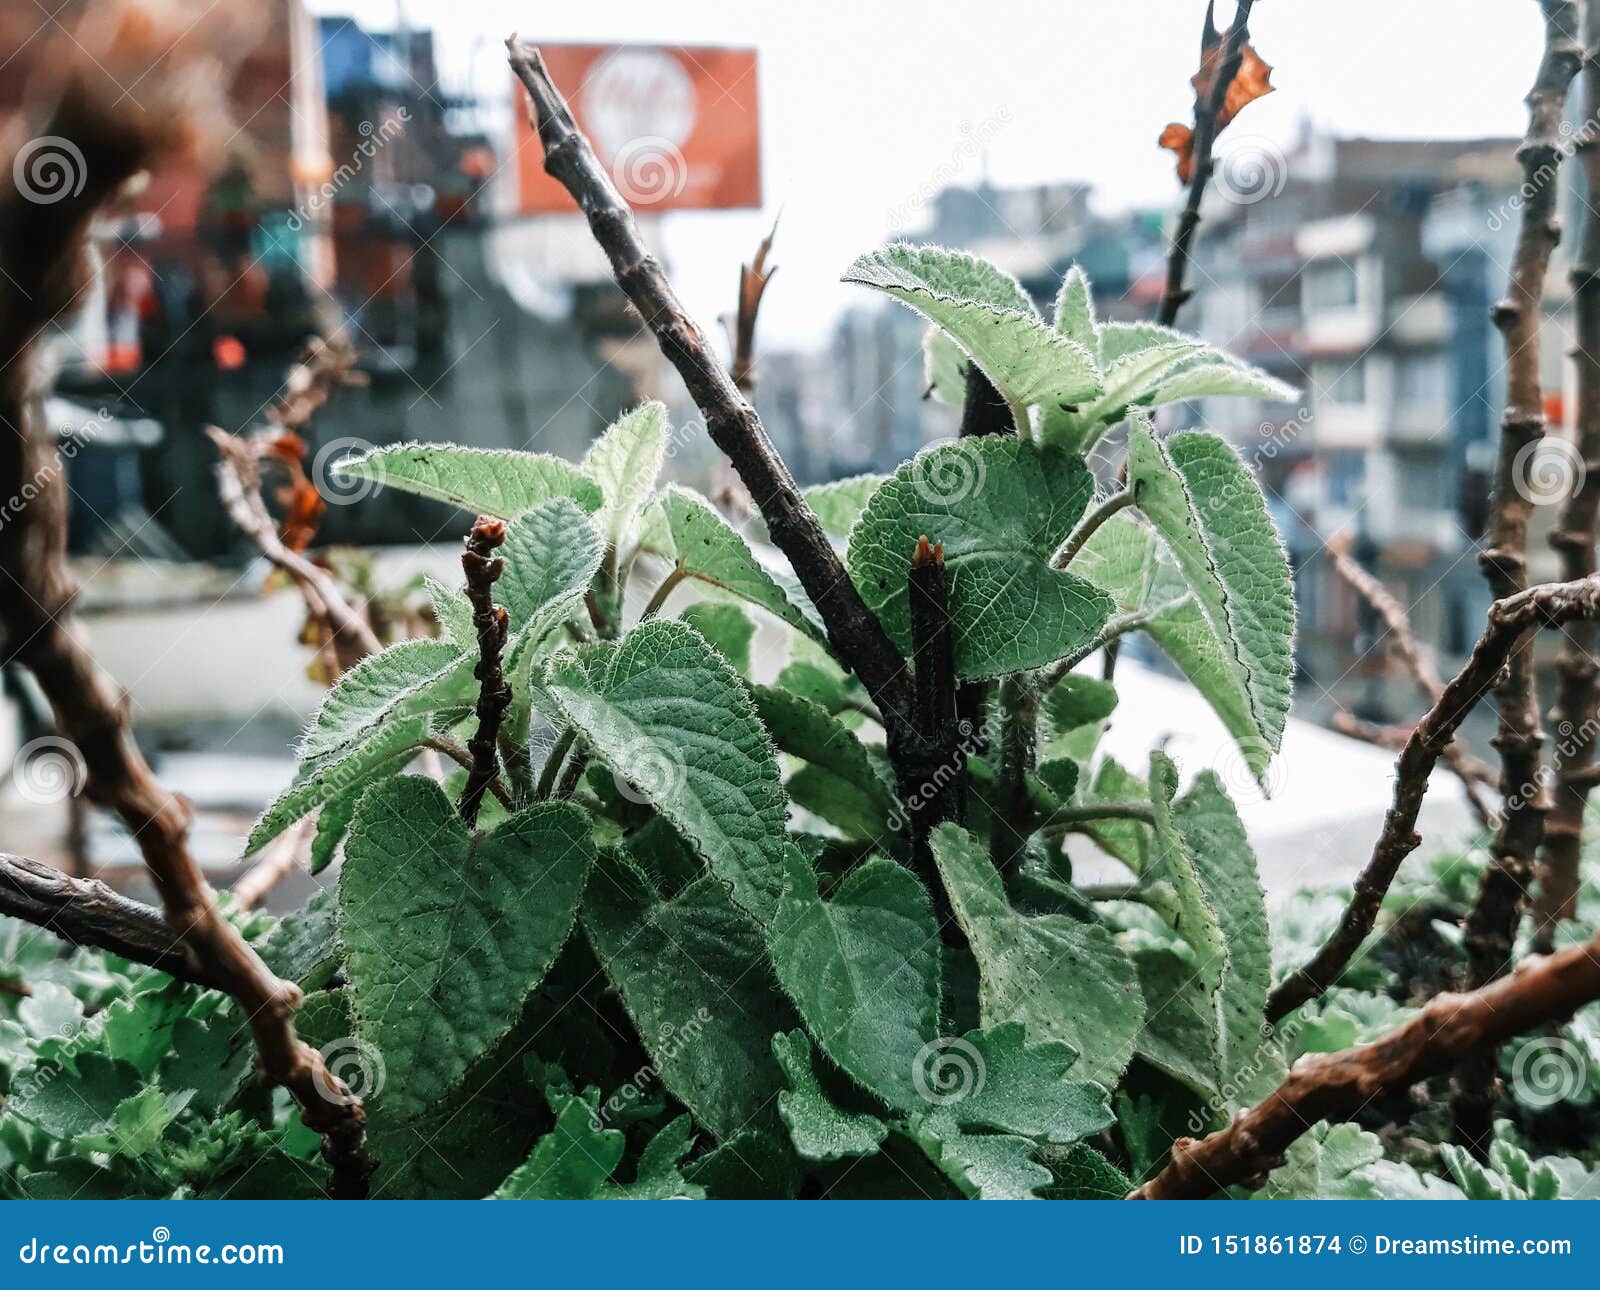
(1128, 936, 1600, 1200)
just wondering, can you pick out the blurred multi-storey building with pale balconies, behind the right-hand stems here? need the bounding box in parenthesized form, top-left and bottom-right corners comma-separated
(1184, 131, 1548, 719)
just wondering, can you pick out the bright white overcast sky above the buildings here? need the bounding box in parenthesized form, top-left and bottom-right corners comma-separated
(310, 0, 1542, 343)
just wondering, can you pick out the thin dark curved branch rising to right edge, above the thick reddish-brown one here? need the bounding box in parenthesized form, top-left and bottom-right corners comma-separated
(1267, 576, 1600, 1021)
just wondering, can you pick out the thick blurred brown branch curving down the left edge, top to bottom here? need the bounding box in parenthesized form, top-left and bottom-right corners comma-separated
(0, 3, 373, 1197)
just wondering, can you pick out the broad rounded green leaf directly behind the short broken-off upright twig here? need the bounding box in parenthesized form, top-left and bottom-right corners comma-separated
(846, 437, 1112, 677)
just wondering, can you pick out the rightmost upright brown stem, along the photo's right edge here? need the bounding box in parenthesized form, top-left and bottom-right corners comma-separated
(1533, 0, 1600, 952)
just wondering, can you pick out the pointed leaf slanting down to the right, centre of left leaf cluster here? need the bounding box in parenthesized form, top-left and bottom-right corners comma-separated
(546, 619, 787, 922)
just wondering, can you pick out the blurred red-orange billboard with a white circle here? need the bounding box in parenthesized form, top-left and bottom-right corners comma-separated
(514, 45, 762, 214)
